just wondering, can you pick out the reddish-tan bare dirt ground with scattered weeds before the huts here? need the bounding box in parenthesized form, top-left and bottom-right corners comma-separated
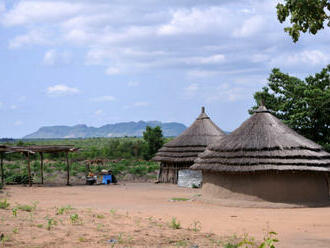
(0, 183, 330, 248)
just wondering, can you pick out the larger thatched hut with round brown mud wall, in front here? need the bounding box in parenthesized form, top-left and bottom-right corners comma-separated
(191, 106, 330, 202)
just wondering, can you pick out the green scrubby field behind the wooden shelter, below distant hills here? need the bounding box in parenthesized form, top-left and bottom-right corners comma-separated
(0, 138, 168, 183)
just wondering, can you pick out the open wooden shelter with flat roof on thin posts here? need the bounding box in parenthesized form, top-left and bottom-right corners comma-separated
(0, 145, 79, 186)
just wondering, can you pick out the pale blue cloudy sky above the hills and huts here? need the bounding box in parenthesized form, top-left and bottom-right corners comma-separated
(0, 0, 330, 138)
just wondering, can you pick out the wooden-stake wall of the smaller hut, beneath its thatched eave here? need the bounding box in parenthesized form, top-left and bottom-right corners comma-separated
(158, 162, 193, 184)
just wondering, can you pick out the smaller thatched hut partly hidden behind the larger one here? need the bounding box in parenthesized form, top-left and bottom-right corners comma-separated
(153, 107, 225, 184)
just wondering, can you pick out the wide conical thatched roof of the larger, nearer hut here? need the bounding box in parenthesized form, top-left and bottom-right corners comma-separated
(191, 106, 330, 172)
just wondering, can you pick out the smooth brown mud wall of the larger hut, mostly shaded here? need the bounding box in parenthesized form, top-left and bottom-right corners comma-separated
(202, 171, 329, 203)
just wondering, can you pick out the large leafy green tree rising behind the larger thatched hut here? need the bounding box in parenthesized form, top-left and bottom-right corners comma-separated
(249, 65, 330, 151)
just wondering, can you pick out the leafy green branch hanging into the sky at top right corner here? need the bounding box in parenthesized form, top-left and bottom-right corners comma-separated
(276, 0, 330, 42)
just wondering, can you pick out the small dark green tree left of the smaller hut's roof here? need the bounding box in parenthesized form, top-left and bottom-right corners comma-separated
(143, 126, 164, 160)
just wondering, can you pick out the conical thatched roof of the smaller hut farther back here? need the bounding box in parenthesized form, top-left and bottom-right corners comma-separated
(153, 107, 225, 162)
